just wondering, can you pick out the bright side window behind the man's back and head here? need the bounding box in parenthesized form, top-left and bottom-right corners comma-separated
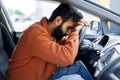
(2, 0, 59, 32)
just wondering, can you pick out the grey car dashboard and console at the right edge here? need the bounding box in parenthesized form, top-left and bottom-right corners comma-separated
(94, 34, 120, 80)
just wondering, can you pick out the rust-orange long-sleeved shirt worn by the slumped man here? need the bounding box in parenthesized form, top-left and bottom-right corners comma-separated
(7, 18, 78, 80)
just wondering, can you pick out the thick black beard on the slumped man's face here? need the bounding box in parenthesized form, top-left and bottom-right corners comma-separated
(52, 23, 66, 40)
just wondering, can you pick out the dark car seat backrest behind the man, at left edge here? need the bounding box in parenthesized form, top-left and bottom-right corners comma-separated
(0, 23, 15, 79)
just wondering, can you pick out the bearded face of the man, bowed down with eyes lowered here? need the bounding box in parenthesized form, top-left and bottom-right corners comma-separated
(52, 19, 75, 40)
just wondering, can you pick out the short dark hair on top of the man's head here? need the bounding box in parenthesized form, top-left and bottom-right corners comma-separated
(49, 3, 83, 22)
